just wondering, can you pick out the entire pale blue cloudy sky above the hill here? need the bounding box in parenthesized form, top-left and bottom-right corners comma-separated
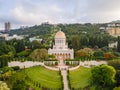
(0, 0, 120, 30)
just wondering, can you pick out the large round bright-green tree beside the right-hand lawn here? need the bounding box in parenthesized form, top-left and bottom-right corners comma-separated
(91, 65, 116, 87)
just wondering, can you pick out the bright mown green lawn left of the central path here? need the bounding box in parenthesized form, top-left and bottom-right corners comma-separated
(25, 66, 62, 88)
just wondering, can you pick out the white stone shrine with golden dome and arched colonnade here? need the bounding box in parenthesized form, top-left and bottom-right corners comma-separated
(48, 31, 74, 60)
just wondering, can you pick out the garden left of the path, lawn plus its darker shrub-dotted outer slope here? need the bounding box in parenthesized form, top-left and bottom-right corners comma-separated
(9, 66, 62, 90)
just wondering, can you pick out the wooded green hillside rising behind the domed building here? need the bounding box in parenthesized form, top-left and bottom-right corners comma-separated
(3, 23, 117, 51)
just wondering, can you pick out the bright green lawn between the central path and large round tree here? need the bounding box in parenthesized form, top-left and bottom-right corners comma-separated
(69, 67, 91, 88)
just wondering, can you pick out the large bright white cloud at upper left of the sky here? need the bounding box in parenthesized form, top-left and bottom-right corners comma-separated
(11, 0, 63, 24)
